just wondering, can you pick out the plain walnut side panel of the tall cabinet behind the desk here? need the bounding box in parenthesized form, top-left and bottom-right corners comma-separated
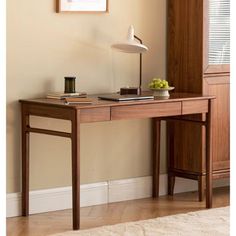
(167, 0, 205, 201)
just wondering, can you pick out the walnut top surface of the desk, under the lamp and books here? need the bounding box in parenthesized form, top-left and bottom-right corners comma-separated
(20, 92, 215, 109)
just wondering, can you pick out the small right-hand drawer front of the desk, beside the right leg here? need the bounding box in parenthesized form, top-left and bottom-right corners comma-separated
(182, 100, 208, 115)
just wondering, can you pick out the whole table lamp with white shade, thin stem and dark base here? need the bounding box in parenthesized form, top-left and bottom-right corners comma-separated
(111, 25, 148, 95)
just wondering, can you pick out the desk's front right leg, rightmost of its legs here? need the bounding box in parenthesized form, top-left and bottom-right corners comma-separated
(206, 100, 213, 208)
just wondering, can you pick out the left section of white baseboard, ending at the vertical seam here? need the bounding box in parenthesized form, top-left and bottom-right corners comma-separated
(7, 182, 108, 217)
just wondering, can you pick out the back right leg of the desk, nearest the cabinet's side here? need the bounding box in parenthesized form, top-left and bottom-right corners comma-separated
(152, 118, 161, 198)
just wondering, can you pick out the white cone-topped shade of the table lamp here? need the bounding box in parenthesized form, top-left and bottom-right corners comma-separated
(111, 26, 148, 53)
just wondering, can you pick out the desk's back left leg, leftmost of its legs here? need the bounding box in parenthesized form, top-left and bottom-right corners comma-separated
(21, 105, 29, 216)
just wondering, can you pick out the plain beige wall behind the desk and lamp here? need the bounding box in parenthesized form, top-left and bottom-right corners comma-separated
(7, 0, 166, 192)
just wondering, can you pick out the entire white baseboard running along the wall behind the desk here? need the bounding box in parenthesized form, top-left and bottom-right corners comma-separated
(7, 174, 229, 217)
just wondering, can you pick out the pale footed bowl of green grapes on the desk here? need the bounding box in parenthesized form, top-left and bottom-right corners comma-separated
(148, 78, 174, 97)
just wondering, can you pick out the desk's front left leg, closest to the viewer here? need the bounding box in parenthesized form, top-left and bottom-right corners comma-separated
(71, 110, 80, 230)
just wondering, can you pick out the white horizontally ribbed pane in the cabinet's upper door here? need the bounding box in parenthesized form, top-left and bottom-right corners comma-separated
(208, 0, 230, 64)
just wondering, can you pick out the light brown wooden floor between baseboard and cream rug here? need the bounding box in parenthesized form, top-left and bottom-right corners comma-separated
(7, 187, 229, 236)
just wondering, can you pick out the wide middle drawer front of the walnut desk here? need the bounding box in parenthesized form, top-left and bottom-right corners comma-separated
(111, 102, 181, 120)
